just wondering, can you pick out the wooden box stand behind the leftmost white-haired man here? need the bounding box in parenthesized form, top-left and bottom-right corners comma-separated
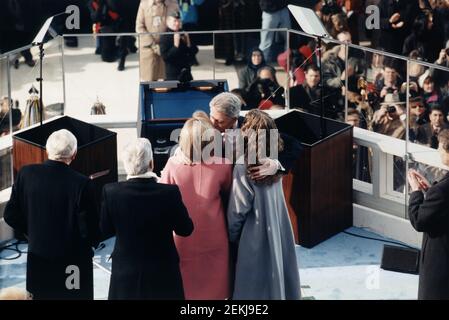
(13, 116, 118, 204)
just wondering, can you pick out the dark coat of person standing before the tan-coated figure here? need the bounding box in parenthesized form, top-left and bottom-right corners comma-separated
(159, 30, 198, 81)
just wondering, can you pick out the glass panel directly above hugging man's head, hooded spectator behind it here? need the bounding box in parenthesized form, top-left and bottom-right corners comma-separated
(214, 31, 288, 110)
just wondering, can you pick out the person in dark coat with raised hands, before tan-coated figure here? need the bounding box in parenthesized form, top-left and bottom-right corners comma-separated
(159, 11, 198, 82)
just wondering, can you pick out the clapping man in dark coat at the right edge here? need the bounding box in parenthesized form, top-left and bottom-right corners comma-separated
(408, 129, 449, 300)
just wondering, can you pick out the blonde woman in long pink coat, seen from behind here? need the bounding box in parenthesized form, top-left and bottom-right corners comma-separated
(161, 115, 232, 300)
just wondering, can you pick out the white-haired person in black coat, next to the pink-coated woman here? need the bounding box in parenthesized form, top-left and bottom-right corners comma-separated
(100, 138, 193, 300)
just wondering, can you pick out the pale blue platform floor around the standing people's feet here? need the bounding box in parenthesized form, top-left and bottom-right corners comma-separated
(0, 227, 418, 300)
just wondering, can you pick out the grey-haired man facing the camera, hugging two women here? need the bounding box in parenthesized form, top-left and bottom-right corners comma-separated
(209, 92, 302, 180)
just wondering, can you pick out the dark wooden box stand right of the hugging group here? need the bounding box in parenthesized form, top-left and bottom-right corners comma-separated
(276, 110, 353, 248)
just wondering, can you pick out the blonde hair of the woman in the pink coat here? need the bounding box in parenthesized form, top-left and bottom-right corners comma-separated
(179, 112, 215, 164)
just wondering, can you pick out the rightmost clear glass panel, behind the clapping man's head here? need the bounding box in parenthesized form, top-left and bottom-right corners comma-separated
(406, 58, 449, 217)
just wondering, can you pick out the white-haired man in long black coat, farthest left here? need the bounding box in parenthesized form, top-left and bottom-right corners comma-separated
(4, 129, 99, 299)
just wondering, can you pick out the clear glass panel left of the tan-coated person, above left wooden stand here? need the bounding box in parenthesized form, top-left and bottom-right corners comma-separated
(64, 34, 139, 121)
